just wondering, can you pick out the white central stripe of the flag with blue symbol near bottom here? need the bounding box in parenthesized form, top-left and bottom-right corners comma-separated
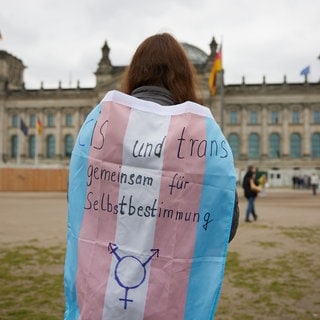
(103, 109, 170, 320)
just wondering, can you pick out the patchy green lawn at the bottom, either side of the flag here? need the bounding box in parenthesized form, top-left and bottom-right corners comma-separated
(0, 227, 320, 320)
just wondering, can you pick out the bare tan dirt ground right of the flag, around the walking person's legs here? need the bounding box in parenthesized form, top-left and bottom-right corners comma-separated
(229, 189, 320, 258)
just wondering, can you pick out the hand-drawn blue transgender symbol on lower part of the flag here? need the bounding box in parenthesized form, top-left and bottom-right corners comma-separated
(108, 243, 159, 309)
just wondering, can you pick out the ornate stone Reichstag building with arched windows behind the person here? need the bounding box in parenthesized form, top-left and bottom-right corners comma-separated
(0, 38, 320, 186)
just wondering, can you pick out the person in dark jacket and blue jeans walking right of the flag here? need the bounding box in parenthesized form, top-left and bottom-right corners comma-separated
(242, 165, 261, 222)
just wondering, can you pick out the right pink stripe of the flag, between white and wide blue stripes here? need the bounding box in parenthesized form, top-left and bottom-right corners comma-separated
(144, 114, 206, 319)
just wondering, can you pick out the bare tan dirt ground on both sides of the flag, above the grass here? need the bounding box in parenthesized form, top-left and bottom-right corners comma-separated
(0, 189, 320, 248)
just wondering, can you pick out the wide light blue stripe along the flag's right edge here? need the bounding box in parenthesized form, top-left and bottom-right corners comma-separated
(184, 119, 236, 320)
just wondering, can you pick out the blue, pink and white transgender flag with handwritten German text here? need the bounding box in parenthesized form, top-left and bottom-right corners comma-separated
(65, 91, 236, 320)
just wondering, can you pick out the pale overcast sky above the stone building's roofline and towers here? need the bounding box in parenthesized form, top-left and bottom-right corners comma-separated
(0, 0, 320, 88)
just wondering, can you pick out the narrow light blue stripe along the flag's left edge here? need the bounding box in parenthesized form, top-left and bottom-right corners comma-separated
(64, 104, 101, 320)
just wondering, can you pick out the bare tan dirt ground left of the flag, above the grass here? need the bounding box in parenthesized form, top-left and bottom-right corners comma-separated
(0, 192, 67, 246)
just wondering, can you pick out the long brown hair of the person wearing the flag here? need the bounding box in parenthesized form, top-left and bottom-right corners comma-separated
(121, 33, 200, 103)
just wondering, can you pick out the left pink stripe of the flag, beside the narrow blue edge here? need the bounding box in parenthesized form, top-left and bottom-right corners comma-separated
(77, 102, 130, 319)
